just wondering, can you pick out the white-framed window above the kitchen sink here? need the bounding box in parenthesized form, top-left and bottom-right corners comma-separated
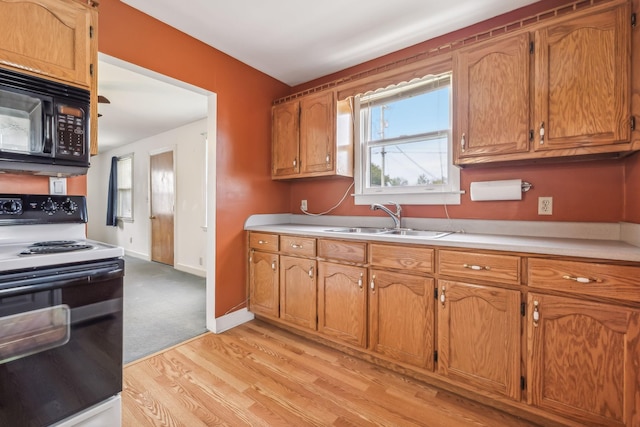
(355, 72, 460, 204)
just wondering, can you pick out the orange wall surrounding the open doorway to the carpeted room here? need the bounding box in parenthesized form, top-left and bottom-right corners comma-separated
(99, 0, 289, 317)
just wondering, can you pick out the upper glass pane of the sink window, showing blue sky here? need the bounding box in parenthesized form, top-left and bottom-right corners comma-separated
(368, 86, 450, 141)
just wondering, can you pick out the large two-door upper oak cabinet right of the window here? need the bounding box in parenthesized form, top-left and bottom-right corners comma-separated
(454, 2, 632, 165)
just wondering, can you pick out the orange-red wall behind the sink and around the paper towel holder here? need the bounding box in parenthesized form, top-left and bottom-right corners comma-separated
(289, 0, 640, 226)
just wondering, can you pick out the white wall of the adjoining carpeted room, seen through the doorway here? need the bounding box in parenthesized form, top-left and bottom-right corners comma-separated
(87, 119, 207, 277)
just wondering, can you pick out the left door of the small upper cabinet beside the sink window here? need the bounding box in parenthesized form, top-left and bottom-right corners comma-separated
(271, 101, 300, 178)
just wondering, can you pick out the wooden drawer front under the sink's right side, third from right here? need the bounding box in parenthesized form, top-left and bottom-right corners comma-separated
(369, 243, 434, 273)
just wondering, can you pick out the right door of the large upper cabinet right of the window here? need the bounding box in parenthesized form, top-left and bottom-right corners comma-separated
(534, 3, 631, 150)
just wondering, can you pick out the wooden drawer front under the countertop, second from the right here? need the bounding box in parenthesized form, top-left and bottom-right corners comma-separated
(438, 250, 520, 285)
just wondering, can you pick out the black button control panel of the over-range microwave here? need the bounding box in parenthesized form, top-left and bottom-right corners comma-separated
(56, 105, 86, 158)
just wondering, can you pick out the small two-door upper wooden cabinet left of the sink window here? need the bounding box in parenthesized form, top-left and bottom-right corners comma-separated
(272, 91, 353, 179)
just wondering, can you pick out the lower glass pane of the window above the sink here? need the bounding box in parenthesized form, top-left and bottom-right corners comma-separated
(367, 134, 449, 188)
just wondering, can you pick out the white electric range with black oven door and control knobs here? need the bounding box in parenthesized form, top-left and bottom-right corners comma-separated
(0, 194, 124, 427)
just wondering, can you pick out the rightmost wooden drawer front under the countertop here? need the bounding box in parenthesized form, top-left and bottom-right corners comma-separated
(528, 258, 640, 302)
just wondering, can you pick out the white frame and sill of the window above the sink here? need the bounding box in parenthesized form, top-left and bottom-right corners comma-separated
(354, 73, 462, 205)
